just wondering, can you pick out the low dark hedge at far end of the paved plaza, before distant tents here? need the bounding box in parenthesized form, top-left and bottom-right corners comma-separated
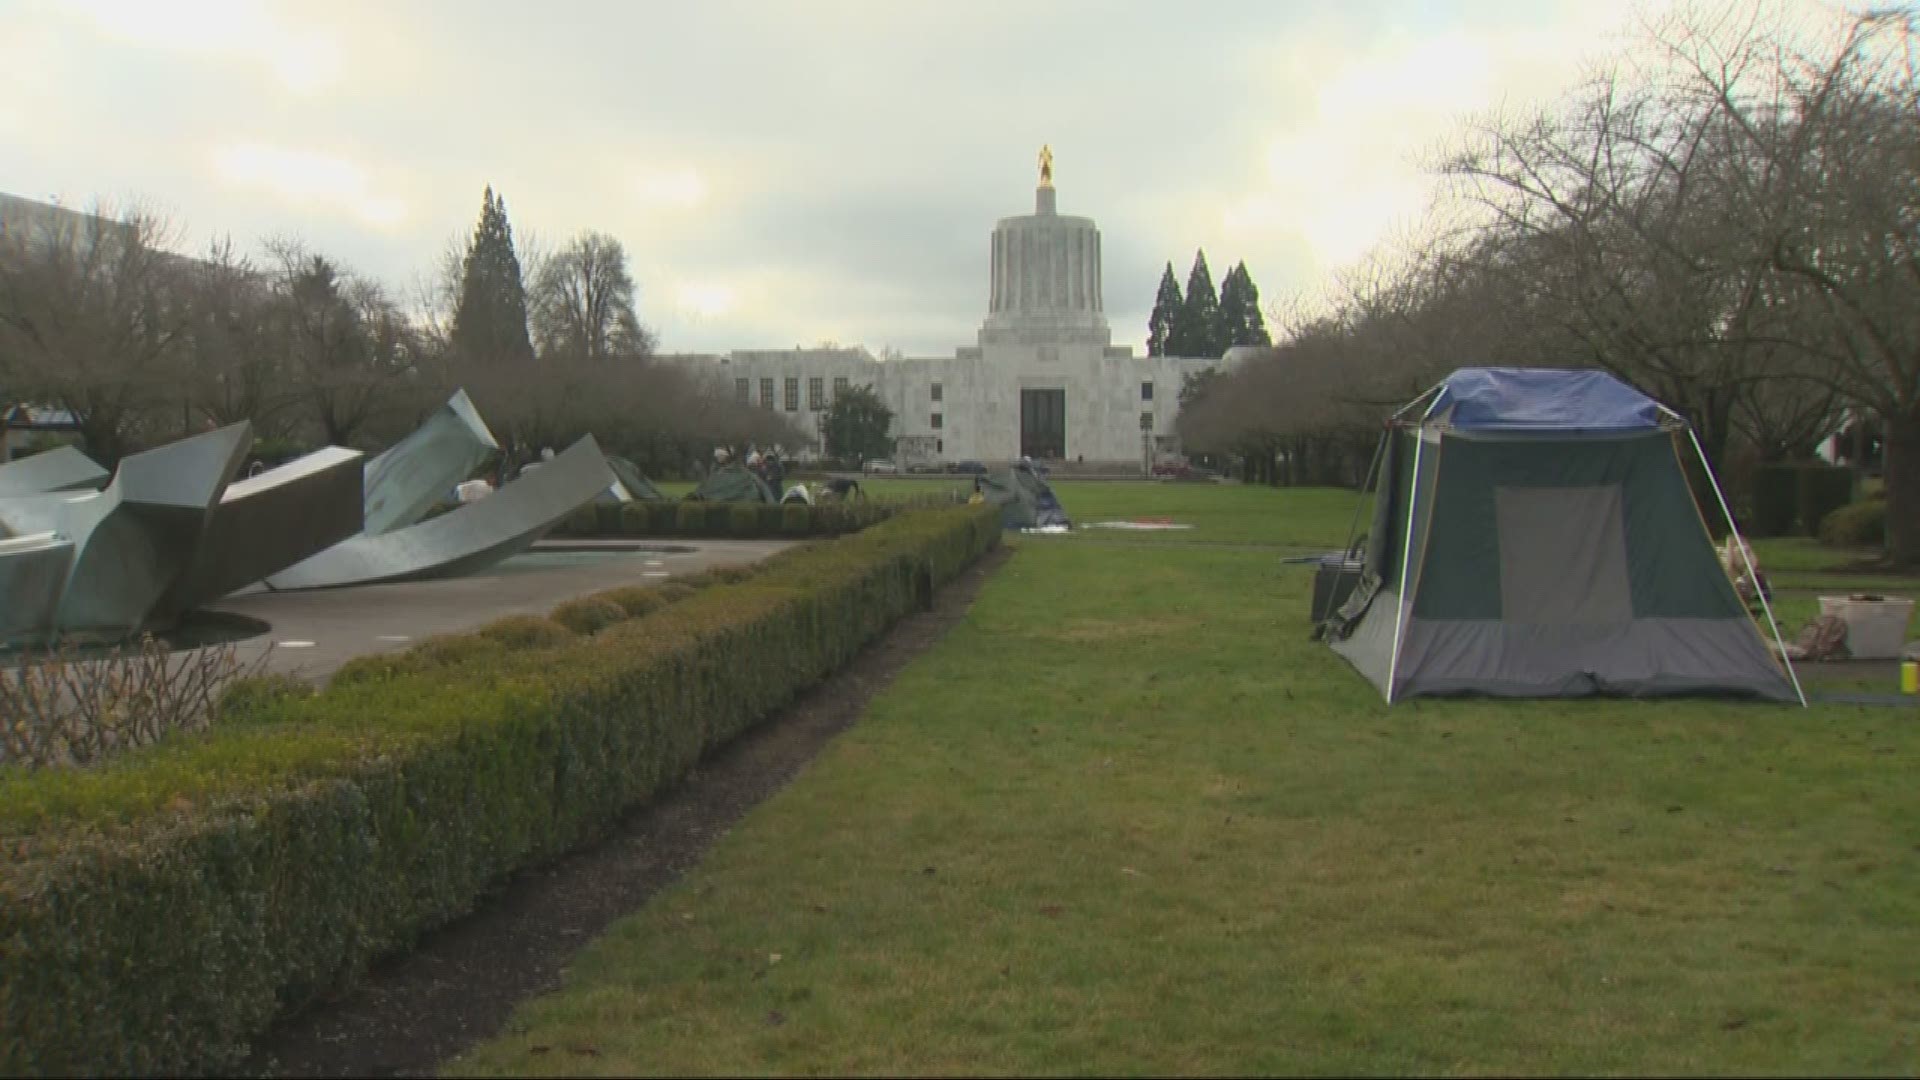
(553, 500, 897, 540)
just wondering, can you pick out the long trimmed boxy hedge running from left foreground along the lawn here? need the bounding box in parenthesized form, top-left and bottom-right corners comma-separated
(0, 507, 1000, 1074)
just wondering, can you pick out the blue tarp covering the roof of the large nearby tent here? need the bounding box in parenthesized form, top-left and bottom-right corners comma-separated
(1428, 367, 1661, 432)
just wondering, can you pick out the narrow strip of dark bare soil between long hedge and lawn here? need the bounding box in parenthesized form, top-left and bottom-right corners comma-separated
(242, 548, 1010, 1076)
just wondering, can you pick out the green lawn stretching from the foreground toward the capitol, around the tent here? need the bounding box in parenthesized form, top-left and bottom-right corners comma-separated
(449, 484, 1920, 1076)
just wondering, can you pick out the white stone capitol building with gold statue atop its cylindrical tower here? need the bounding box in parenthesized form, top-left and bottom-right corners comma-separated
(662, 152, 1221, 469)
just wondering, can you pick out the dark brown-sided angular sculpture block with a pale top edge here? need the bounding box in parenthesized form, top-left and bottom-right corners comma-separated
(154, 446, 367, 621)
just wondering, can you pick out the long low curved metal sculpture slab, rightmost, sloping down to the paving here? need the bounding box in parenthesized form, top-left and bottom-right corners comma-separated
(267, 434, 614, 590)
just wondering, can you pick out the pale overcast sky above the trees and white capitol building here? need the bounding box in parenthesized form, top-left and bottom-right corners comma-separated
(0, 0, 1666, 356)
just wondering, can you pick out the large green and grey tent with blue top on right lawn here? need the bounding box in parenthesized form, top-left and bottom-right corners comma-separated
(1319, 367, 1805, 703)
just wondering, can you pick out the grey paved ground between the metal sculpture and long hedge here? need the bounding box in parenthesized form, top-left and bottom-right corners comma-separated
(211, 540, 791, 680)
